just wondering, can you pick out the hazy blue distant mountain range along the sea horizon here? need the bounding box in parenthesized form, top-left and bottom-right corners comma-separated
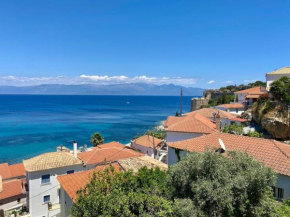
(0, 83, 204, 96)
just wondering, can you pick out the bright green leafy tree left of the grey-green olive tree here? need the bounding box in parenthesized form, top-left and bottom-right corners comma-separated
(71, 167, 173, 217)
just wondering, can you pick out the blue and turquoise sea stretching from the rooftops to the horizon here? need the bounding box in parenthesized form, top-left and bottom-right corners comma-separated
(0, 95, 196, 164)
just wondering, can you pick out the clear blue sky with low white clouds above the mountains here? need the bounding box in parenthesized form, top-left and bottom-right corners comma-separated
(0, 0, 290, 88)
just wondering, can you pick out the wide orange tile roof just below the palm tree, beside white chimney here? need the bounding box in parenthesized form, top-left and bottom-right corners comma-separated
(78, 143, 144, 165)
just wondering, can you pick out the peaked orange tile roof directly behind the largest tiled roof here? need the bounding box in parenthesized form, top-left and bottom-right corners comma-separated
(166, 113, 217, 134)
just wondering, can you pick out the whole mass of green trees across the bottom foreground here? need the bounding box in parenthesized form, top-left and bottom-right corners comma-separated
(71, 151, 280, 217)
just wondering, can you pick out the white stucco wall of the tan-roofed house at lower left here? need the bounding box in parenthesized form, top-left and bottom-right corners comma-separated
(27, 165, 83, 217)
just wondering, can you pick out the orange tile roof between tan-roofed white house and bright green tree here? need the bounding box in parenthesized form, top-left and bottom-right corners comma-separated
(57, 163, 121, 201)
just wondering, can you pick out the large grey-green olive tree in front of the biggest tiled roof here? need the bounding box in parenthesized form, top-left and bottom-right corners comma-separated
(168, 151, 277, 217)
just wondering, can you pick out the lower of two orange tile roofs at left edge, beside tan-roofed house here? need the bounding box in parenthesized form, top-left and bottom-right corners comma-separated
(0, 179, 23, 201)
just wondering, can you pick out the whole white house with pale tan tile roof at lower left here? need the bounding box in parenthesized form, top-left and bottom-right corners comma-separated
(23, 151, 83, 217)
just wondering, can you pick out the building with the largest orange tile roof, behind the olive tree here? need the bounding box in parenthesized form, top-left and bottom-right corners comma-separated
(167, 133, 290, 200)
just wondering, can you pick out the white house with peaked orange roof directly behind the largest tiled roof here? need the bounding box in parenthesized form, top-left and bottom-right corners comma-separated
(164, 113, 220, 142)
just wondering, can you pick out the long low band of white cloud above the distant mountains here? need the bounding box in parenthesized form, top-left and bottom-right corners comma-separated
(0, 74, 197, 86)
